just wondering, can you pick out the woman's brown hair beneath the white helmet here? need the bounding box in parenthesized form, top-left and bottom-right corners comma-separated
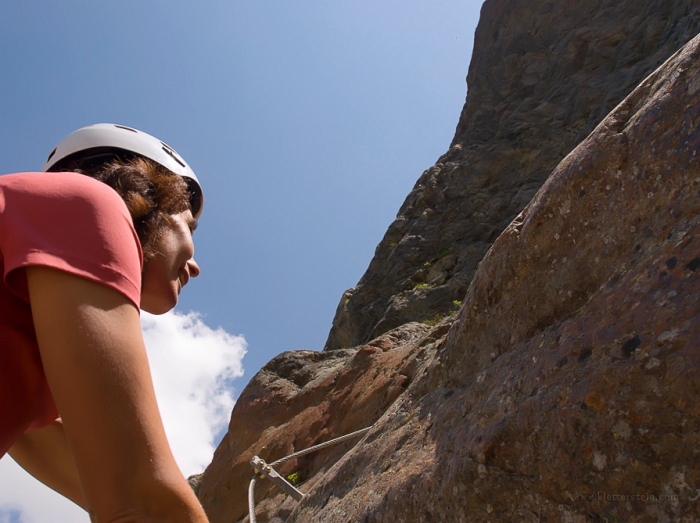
(51, 156, 191, 266)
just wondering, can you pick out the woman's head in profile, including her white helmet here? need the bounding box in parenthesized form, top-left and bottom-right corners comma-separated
(43, 124, 203, 314)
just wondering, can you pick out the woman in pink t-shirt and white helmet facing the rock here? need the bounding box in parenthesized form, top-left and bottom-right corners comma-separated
(0, 124, 207, 523)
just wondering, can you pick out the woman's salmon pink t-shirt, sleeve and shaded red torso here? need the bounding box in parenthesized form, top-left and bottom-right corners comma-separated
(0, 173, 142, 457)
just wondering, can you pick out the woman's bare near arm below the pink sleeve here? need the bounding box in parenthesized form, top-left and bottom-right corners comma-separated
(27, 267, 207, 523)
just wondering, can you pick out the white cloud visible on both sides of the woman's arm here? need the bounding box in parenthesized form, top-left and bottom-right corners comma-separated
(0, 312, 247, 523)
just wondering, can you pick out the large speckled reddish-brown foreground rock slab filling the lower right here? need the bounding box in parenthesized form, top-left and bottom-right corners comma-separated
(287, 29, 700, 523)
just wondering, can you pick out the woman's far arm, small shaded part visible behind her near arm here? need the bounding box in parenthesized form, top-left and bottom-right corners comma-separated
(9, 419, 85, 508)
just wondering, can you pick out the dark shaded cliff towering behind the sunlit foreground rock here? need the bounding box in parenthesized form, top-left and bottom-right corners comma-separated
(325, 0, 700, 350)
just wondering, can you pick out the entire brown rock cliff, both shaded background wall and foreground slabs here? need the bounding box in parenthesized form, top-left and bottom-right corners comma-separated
(194, 0, 700, 523)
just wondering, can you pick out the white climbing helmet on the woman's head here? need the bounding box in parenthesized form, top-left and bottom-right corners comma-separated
(41, 123, 204, 218)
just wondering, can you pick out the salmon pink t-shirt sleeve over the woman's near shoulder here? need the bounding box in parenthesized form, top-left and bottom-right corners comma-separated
(0, 173, 143, 309)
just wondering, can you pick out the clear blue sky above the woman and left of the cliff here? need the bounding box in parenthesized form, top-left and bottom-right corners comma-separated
(0, 0, 482, 521)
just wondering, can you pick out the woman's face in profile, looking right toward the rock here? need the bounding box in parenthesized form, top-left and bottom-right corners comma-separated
(141, 210, 199, 314)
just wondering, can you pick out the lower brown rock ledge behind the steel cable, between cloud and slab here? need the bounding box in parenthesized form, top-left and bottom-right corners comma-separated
(196, 323, 442, 523)
